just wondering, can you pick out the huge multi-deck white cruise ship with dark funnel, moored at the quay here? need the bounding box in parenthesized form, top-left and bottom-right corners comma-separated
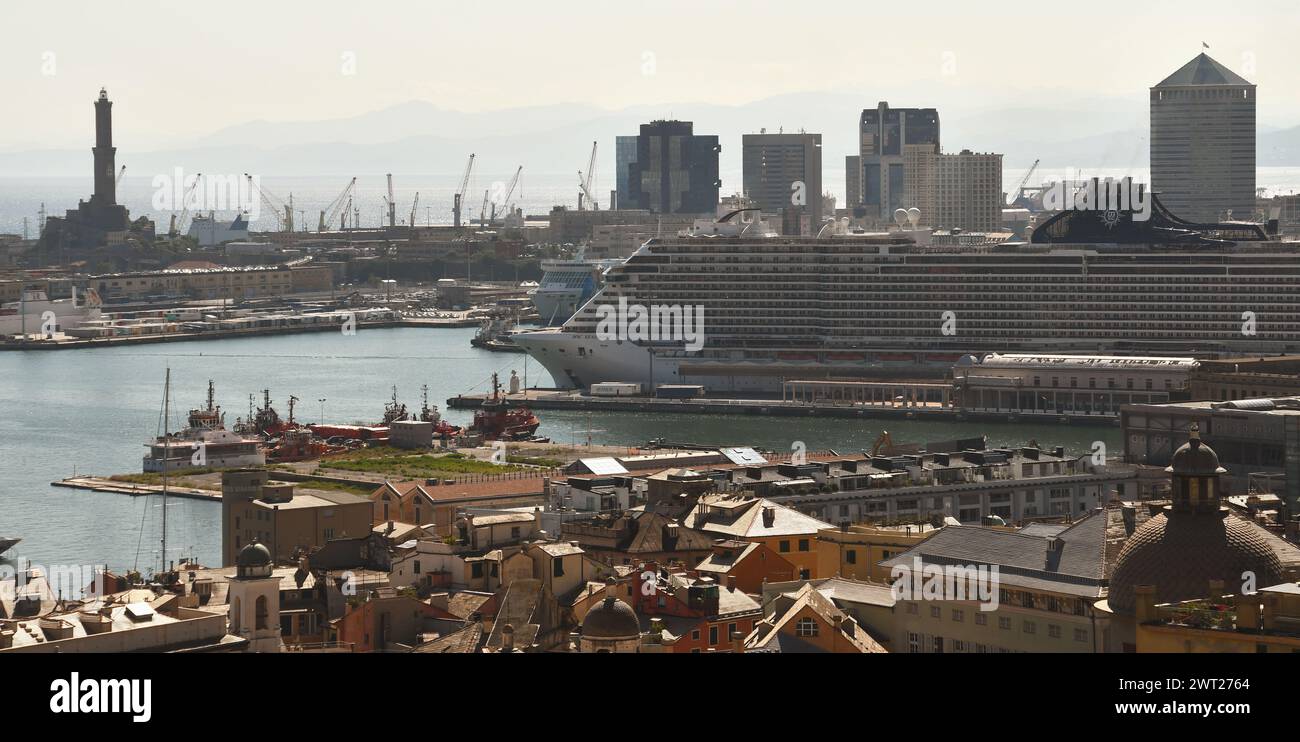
(515, 195, 1300, 394)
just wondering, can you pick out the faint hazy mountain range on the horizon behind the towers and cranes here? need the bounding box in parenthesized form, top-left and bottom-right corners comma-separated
(0, 94, 1300, 180)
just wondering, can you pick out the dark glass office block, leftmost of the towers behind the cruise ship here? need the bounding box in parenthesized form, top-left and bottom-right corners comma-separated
(620, 121, 722, 214)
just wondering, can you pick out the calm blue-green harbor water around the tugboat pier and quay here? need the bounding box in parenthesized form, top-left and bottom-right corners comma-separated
(0, 327, 1121, 572)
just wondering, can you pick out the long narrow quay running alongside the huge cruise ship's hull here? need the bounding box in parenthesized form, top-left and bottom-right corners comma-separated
(447, 389, 1119, 426)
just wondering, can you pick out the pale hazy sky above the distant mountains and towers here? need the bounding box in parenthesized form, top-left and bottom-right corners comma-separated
(0, 0, 1300, 149)
